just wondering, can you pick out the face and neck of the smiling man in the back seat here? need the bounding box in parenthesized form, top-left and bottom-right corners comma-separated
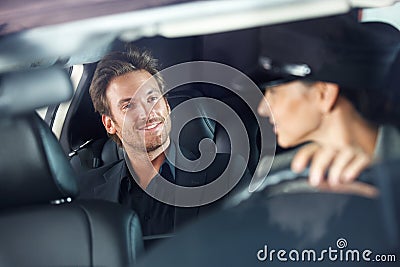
(101, 69, 171, 191)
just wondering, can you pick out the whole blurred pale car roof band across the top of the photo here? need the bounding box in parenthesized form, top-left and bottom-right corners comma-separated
(0, 0, 394, 73)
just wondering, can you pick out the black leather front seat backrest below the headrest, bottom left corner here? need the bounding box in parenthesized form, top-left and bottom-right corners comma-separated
(0, 201, 142, 267)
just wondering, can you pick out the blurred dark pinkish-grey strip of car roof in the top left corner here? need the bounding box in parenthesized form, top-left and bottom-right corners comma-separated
(0, 0, 194, 36)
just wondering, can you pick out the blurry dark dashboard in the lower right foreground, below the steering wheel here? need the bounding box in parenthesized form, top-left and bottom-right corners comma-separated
(139, 164, 400, 267)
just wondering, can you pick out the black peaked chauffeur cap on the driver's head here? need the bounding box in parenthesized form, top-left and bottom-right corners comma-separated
(249, 13, 400, 89)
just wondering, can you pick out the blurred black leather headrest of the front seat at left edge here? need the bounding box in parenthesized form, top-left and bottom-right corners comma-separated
(0, 113, 78, 208)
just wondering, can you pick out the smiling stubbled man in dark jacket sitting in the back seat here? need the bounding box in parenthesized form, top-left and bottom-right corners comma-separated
(80, 49, 250, 235)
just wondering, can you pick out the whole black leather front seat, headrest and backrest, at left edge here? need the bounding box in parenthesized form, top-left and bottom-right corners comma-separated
(0, 114, 143, 266)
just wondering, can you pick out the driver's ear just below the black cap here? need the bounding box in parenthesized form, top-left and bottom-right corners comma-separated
(315, 82, 339, 113)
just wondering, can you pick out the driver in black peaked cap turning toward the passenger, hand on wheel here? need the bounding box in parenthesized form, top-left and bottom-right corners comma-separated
(258, 14, 400, 186)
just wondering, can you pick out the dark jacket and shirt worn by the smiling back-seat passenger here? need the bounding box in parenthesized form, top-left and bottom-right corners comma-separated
(79, 146, 251, 239)
